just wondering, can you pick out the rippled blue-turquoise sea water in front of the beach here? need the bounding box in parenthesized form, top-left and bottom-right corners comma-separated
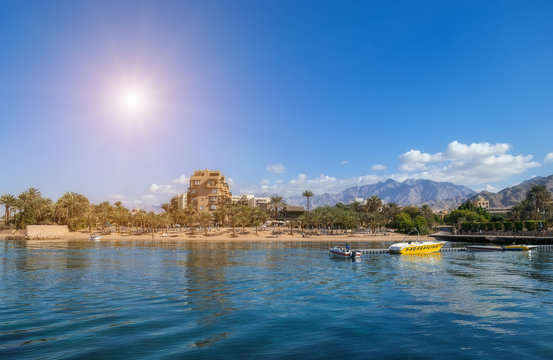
(0, 241, 553, 359)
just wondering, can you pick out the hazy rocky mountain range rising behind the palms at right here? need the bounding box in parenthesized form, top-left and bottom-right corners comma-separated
(256, 175, 553, 210)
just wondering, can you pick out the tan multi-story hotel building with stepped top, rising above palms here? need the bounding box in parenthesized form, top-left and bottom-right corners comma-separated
(187, 169, 232, 213)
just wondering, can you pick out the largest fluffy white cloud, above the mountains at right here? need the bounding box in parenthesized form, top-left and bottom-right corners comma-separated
(399, 141, 540, 185)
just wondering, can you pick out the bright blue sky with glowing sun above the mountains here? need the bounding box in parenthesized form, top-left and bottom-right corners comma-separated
(0, 0, 553, 207)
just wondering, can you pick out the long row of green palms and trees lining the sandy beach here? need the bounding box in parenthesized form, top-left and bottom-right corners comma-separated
(8, 185, 553, 234)
